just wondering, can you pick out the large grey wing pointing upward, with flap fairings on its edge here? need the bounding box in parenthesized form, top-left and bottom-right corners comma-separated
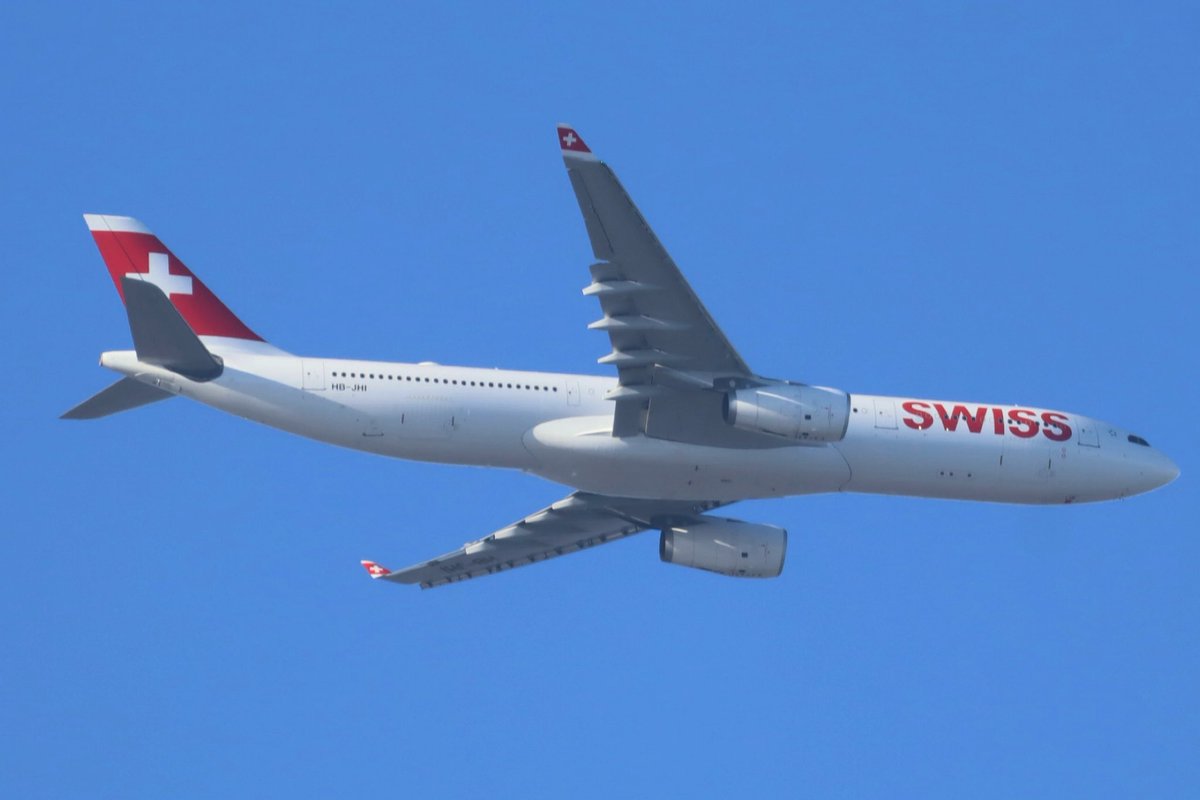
(558, 125, 773, 446)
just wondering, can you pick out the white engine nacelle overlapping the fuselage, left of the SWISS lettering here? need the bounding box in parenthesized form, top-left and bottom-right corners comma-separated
(724, 384, 850, 441)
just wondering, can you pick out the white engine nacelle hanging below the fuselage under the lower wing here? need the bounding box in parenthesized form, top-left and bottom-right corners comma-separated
(659, 517, 787, 578)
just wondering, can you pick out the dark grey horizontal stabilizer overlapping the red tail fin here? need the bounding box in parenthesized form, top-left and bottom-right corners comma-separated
(121, 276, 223, 380)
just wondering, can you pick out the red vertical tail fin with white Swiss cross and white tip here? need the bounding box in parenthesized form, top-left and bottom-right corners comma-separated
(83, 213, 263, 342)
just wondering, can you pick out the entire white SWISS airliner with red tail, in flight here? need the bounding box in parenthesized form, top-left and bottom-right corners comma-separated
(62, 125, 1180, 589)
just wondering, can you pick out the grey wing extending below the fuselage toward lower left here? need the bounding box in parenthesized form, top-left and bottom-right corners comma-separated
(362, 492, 721, 589)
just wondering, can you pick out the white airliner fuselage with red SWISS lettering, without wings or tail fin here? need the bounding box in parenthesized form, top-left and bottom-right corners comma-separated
(101, 337, 1177, 504)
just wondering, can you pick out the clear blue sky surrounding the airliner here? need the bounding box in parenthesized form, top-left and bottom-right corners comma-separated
(0, 2, 1200, 798)
